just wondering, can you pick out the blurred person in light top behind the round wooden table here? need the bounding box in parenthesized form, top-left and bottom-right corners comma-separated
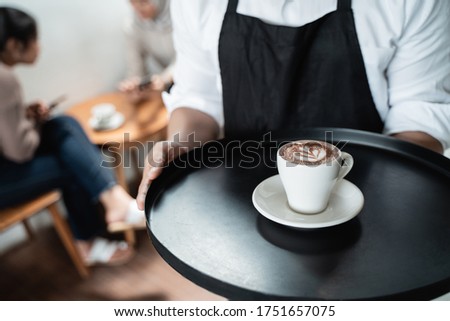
(119, 0, 175, 103)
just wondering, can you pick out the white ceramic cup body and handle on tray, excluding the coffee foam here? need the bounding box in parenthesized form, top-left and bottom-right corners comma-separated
(277, 140, 353, 214)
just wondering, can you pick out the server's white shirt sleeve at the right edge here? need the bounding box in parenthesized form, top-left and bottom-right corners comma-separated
(384, 0, 450, 149)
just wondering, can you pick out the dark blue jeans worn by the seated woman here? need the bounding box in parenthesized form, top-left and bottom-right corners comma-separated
(0, 116, 116, 240)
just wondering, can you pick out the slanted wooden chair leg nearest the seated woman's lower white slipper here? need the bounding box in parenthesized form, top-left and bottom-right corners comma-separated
(48, 203, 89, 278)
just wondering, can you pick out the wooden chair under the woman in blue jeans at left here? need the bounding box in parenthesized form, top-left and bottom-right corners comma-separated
(0, 191, 89, 278)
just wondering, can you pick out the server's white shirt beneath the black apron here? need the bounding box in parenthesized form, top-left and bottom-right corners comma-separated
(163, 0, 450, 148)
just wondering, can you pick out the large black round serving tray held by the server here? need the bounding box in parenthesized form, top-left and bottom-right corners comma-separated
(146, 128, 450, 300)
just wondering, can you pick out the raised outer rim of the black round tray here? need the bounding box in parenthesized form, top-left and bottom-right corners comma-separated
(145, 128, 450, 300)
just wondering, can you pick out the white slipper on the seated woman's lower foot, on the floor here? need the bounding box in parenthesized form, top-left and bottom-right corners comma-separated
(85, 237, 134, 266)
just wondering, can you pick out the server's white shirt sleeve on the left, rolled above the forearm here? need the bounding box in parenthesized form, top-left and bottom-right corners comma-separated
(163, 0, 224, 126)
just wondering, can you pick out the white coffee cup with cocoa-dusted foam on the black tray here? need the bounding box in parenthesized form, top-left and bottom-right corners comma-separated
(277, 140, 353, 214)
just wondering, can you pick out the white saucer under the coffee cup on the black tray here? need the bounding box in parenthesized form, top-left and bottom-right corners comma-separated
(252, 175, 364, 228)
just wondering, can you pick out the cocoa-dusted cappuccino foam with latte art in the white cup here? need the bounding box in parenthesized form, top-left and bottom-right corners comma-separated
(279, 140, 339, 165)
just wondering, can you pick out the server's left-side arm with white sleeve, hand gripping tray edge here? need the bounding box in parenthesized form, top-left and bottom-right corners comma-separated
(137, 0, 226, 209)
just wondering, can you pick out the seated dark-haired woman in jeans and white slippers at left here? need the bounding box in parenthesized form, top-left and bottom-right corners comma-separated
(0, 7, 145, 265)
